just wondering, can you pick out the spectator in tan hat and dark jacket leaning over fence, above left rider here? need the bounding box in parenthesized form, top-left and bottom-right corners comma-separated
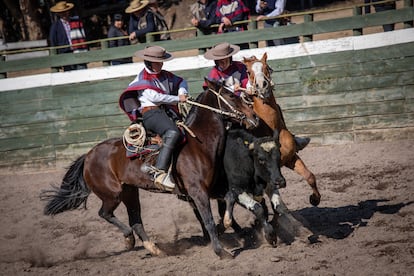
(125, 0, 160, 44)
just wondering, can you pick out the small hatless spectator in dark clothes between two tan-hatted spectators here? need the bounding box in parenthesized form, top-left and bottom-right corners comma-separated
(108, 13, 132, 65)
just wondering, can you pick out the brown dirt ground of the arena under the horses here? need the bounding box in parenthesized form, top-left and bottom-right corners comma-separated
(0, 140, 414, 275)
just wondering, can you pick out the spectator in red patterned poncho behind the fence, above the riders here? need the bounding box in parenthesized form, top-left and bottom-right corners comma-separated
(216, 0, 250, 49)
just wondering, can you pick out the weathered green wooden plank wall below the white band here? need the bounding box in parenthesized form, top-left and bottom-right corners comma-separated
(0, 42, 414, 172)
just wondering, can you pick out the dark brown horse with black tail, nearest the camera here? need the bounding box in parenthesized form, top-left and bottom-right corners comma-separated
(41, 79, 257, 258)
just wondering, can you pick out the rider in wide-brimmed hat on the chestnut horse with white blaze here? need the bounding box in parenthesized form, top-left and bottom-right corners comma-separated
(203, 42, 310, 151)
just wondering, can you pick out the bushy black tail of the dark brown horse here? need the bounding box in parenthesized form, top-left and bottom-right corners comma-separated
(40, 154, 91, 215)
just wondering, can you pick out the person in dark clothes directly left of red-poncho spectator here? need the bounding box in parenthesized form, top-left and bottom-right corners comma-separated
(190, 0, 220, 35)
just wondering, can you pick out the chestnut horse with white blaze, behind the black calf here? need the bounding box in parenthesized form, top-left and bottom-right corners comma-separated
(243, 53, 321, 212)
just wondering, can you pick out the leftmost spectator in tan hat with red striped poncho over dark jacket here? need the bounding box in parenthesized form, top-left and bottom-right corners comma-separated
(49, 1, 88, 71)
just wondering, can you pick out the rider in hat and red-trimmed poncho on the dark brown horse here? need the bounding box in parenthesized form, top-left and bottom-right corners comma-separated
(121, 46, 188, 191)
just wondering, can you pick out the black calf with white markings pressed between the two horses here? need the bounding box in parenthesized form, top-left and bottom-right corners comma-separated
(221, 129, 285, 245)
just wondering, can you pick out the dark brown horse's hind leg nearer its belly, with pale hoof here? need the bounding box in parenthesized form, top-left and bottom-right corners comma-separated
(121, 185, 163, 256)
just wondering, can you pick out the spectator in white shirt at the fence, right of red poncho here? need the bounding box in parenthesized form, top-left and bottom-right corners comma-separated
(256, 0, 299, 47)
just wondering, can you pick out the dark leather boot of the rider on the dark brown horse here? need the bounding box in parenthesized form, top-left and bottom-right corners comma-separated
(154, 130, 180, 191)
